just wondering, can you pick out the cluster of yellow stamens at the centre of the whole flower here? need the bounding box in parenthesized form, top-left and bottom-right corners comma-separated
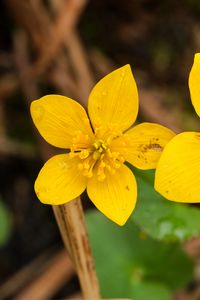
(70, 133, 125, 181)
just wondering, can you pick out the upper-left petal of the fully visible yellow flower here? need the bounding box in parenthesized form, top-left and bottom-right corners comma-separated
(31, 95, 93, 148)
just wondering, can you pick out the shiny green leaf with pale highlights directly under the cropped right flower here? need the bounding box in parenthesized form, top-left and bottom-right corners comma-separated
(131, 170, 200, 242)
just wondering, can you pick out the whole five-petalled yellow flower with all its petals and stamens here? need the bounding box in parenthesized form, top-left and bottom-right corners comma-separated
(31, 65, 174, 225)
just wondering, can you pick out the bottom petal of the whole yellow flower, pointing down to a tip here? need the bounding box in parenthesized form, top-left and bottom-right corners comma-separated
(87, 165, 137, 226)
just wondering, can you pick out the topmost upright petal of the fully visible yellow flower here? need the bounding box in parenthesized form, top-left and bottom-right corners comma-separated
(88, 65, 138, 131)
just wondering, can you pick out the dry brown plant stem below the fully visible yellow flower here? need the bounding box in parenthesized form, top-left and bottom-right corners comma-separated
(53, 198, 101, 300)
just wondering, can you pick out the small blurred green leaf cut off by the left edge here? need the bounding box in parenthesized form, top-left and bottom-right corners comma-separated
(0, 199, 12, 247)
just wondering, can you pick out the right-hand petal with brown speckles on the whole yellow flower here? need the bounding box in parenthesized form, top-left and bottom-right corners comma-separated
(111, 123, 175, 170)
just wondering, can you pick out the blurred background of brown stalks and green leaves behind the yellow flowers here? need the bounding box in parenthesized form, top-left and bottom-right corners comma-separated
(0, 0, 200, 300)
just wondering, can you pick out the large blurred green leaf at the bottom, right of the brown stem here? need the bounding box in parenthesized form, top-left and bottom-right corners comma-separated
(86, 212, 193, 300)
